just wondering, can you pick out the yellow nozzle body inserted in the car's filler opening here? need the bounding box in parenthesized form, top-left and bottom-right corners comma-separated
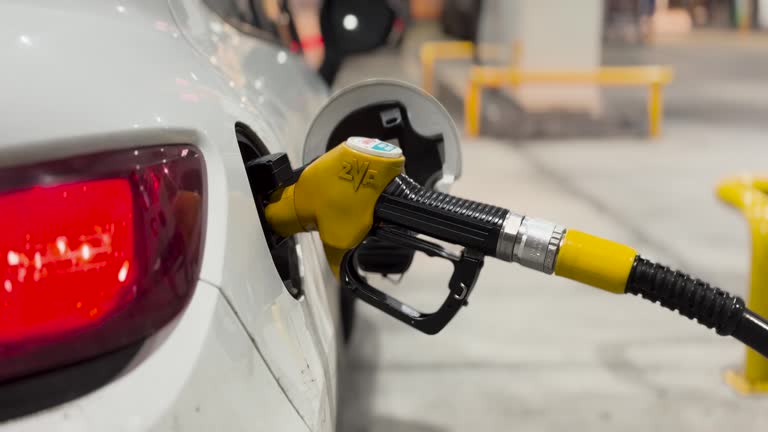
(265, 137, 405, 277)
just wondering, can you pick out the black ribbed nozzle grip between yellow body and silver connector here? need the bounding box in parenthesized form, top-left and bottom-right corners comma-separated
(374, 174, 509, 256)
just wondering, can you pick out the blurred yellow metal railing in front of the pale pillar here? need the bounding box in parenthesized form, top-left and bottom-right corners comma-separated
(464, 66, 673, 137)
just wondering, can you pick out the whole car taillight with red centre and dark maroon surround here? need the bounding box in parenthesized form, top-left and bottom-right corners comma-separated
(0, 145, 204, 380)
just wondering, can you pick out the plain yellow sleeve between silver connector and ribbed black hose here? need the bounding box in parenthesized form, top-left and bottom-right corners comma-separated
(555, 229, 637, 294)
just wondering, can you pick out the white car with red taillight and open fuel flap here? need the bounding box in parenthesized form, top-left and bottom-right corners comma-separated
(0, 0, 460, 431)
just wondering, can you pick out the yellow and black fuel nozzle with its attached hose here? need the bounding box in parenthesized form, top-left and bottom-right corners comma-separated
(265, 137, 768, 356)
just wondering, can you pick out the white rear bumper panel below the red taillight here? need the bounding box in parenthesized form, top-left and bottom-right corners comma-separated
(0, 282, 307, 432)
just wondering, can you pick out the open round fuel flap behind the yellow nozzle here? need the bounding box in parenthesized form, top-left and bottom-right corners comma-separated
(303, 79, 461, 274)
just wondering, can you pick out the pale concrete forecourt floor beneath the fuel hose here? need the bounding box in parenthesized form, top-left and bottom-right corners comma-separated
(334, 28, 768, 432)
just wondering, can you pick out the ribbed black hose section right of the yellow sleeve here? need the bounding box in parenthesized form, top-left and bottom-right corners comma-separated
(625, 256, 768, 357)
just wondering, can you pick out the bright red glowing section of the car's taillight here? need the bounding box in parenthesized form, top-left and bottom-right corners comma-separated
(0, 179, 134, 344)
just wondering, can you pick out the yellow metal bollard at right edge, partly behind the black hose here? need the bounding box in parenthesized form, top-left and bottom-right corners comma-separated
(717, 176, 768, 394)
